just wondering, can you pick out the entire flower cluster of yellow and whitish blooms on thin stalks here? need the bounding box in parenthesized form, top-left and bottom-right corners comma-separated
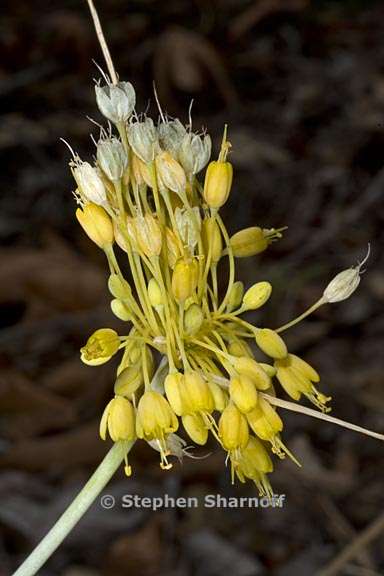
(71, 82, 361, 495)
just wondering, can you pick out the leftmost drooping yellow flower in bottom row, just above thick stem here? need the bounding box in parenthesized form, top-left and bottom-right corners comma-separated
(100, 396, 135, 442)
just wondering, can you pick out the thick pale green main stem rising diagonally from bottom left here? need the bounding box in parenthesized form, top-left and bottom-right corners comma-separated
(13, 442, 133, 576)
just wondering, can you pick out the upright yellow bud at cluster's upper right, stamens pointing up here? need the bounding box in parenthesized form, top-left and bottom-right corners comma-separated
(204, 161, 233, 208)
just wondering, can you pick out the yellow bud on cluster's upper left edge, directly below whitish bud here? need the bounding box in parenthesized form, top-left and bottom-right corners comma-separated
(76, 202, 114, 248)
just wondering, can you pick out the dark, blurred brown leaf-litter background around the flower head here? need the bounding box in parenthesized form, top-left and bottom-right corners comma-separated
(0, 0, 384, 576)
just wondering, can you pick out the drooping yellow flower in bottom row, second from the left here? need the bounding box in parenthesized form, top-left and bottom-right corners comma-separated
(136, 390, 179, 440)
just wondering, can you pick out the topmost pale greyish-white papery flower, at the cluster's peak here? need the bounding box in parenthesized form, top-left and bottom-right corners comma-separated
(95, 82, 136, 124)
